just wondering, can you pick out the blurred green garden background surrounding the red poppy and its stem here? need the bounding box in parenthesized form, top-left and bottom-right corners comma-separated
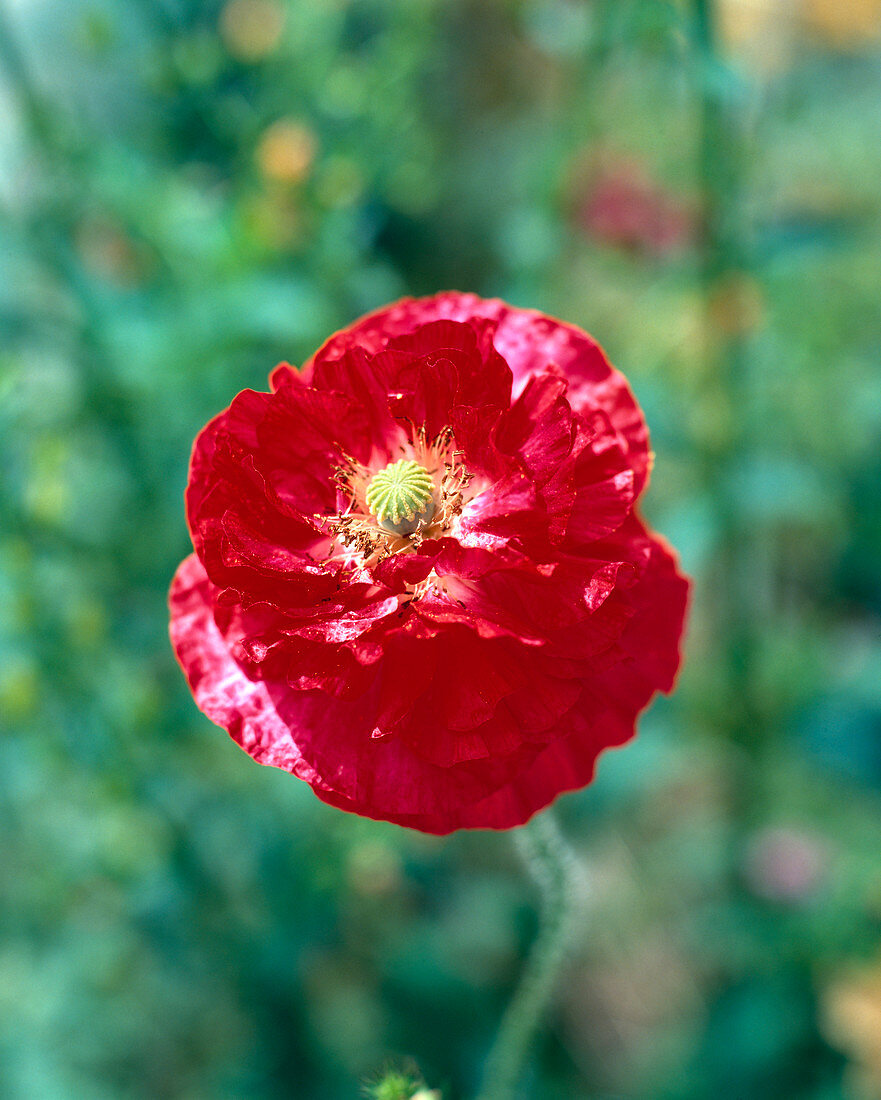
(0, 0, 881, 1100)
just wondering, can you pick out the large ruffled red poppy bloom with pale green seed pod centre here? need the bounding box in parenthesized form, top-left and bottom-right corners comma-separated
(170, 293, 687, 833)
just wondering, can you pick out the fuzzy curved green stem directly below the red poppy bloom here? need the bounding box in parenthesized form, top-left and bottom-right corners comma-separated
(478, 811, 584, 1100)
